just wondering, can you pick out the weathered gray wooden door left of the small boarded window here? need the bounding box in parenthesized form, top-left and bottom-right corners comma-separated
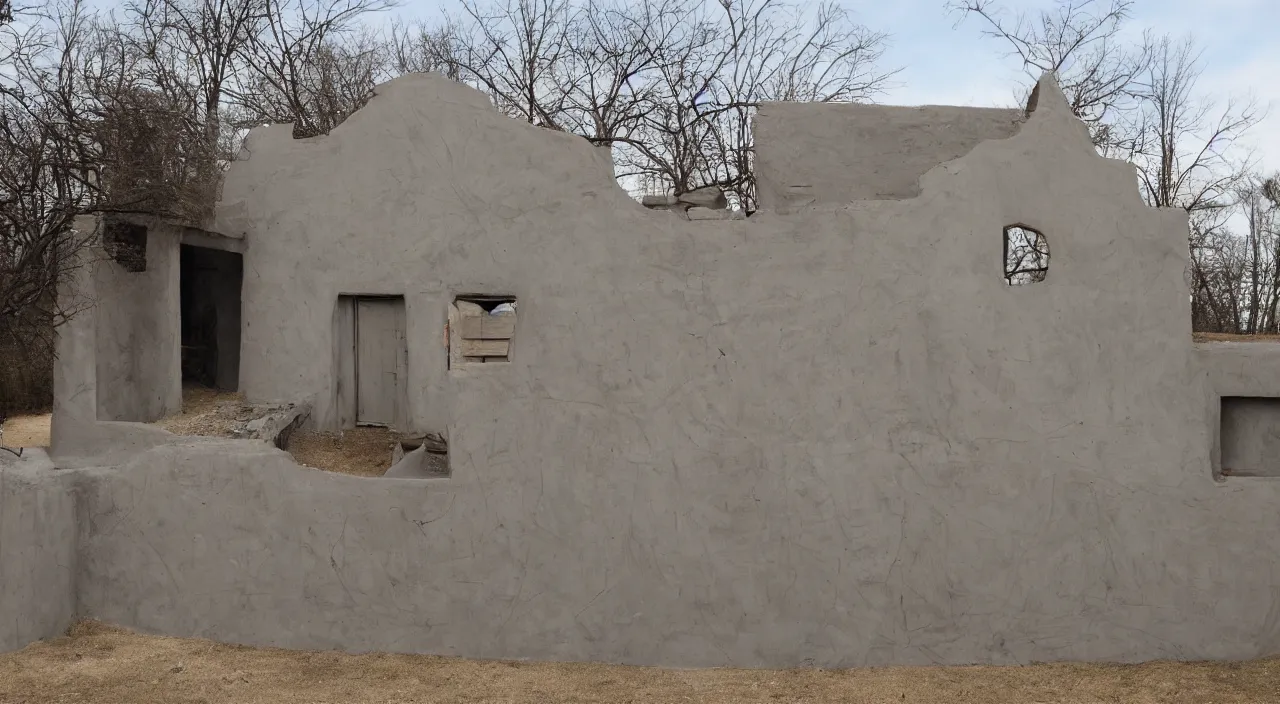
(353, 298, 406, 426)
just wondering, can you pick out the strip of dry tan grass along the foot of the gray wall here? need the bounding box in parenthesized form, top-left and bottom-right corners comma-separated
(0, 622, 1280, 704)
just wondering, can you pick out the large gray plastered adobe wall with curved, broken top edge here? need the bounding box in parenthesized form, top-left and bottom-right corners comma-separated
(17, 76, 1280, 667)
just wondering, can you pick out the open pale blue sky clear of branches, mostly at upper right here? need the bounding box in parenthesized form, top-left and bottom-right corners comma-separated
(396, 0, 1280, 170)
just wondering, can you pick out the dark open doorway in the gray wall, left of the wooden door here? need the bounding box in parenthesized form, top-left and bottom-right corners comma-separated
(180, 244, 244, 392)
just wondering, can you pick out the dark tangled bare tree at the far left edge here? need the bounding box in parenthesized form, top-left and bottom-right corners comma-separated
(0, 0, 100, 373)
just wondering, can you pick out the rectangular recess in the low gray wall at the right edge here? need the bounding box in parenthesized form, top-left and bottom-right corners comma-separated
(1219, 397, 1280, 477)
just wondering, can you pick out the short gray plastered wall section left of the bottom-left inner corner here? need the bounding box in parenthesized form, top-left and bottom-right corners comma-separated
(0, 448, 76, 652)
